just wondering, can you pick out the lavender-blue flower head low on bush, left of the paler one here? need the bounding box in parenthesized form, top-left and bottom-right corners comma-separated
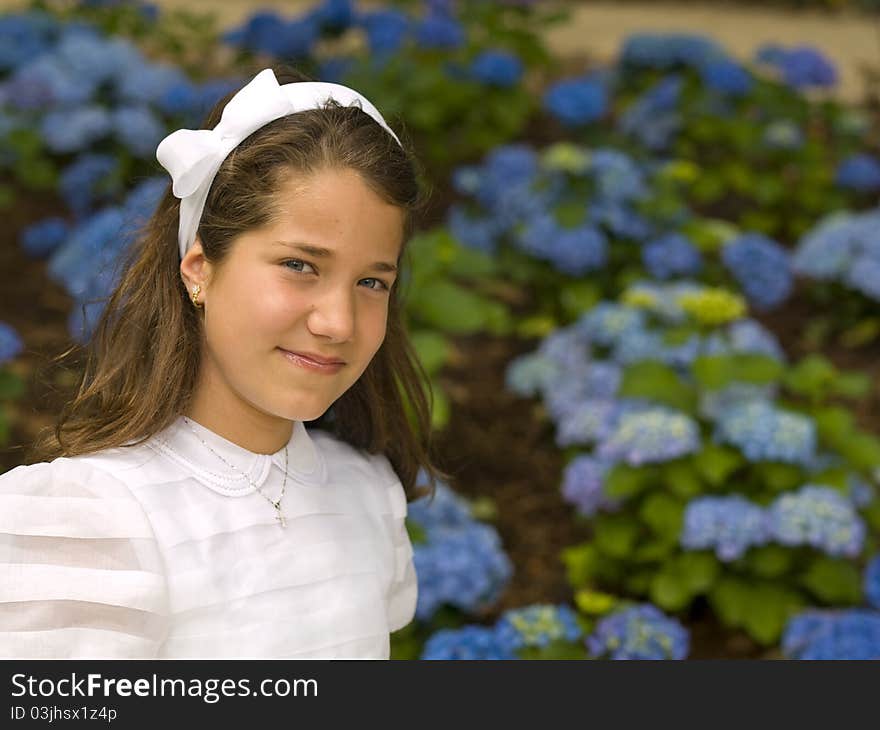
(679, 495, 770, 562)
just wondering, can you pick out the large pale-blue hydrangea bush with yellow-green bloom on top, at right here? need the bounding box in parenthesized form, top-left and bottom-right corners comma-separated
(506, 281, 880, 644)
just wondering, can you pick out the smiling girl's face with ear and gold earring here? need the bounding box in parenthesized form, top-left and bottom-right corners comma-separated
(181, 169, 404, 429)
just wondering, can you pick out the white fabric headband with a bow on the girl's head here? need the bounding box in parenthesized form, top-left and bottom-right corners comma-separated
(156, 68, 403, 259)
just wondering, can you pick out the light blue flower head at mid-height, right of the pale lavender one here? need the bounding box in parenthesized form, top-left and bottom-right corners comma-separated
(715, 401, 816, 466)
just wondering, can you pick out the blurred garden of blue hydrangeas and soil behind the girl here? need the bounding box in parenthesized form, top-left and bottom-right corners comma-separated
(0, 0, 880, 660)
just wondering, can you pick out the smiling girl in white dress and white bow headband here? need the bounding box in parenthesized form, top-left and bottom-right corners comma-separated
(0, 69, 446, 658)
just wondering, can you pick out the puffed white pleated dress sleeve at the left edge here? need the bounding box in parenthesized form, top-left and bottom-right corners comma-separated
(0, 458, 169, 659)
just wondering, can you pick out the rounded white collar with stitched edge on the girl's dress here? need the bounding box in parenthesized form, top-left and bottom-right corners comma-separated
(149, 416, 326, 496)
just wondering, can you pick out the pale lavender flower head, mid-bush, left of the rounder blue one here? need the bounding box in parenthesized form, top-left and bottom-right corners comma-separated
(596, 407, 700, 466)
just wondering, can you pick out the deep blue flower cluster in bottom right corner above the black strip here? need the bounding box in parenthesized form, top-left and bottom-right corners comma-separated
(782, 609, 880, 661)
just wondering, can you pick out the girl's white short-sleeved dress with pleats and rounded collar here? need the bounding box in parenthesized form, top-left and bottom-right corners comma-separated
(0, 417, 417, 659)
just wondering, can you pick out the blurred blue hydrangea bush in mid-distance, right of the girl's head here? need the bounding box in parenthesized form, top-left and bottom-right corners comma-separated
(446, 143, 793, 318)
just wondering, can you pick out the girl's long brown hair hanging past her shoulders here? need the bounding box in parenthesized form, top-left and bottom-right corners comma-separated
(28, 66, 448, 497)
